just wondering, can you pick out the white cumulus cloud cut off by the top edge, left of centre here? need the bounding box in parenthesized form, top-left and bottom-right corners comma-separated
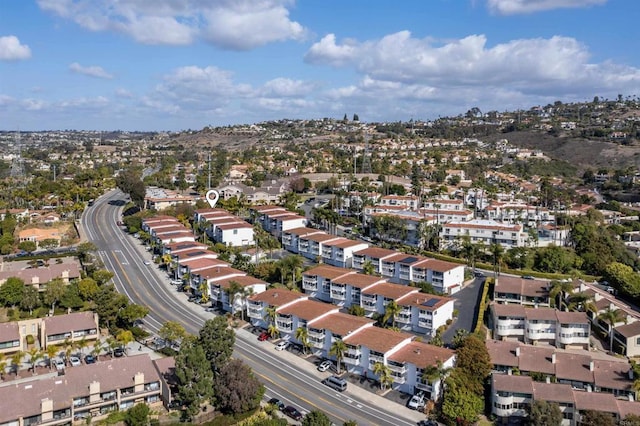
(38, 0, 306, 50)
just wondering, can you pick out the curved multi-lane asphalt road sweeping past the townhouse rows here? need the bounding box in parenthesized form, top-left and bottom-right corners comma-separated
(81, 190, 415, 426)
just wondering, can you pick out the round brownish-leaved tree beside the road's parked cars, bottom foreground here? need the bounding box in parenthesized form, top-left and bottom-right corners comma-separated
(214, 359, 264, 414)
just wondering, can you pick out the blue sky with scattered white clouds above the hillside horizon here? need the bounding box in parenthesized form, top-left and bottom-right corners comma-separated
(0, 0, 640, 130)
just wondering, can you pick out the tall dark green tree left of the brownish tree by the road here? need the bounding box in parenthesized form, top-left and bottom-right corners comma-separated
(175, 338, 213, 419)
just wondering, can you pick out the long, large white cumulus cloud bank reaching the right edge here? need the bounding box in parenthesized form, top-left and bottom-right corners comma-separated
(305, 31, 640, 96)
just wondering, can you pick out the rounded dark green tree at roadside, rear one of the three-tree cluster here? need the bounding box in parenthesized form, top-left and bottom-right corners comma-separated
(198, 316, 236, 374)
